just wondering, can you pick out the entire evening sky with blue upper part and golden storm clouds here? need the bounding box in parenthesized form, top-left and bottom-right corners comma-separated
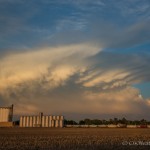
(0, 0, 150, 120)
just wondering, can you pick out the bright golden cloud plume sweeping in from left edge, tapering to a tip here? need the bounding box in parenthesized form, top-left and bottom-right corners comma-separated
(0, 43, 100, 96)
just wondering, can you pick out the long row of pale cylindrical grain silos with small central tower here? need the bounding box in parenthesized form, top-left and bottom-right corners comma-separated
(20, 113, 64, 128)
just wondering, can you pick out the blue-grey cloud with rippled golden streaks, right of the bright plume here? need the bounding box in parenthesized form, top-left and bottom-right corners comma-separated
(77, 51, 150, 95)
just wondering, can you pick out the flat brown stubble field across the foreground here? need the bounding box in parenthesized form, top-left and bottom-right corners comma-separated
(0, 128, 150, 150)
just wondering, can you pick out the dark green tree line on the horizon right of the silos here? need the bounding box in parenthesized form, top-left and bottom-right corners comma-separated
(64, 117, 150, 125)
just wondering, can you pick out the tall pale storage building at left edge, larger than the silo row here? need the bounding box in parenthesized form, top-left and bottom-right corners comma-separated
(0, 105, 13, 127)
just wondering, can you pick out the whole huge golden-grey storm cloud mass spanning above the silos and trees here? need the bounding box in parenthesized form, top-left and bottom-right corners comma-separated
(0, 43, 150, 118)
